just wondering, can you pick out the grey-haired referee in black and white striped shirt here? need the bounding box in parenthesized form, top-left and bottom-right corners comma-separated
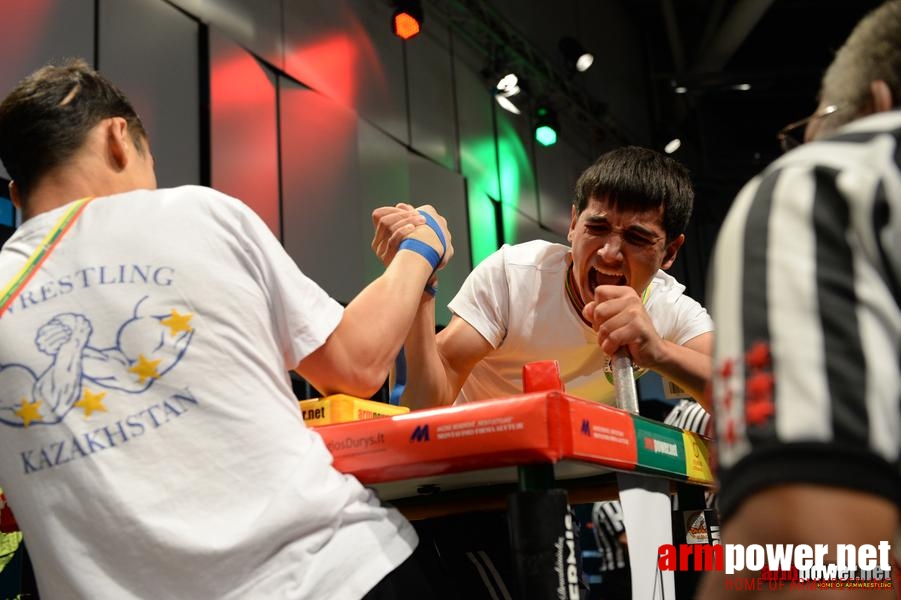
(700, 0, 901, 600)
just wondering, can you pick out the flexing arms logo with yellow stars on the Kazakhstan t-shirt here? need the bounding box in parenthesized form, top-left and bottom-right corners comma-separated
(0, 296, 194, 428)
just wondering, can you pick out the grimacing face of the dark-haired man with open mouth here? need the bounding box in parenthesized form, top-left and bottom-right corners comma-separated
(568, 197, 685, 303)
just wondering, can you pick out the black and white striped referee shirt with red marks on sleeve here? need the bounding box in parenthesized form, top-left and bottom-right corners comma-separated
(710, 110, 901, 519)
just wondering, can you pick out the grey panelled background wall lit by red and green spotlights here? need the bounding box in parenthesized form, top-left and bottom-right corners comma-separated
(0, 0, 660, 323)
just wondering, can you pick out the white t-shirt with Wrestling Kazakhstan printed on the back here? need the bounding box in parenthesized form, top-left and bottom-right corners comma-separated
(0, 186, 416, 600)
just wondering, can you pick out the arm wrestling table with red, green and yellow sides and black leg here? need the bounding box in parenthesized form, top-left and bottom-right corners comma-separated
(316, 391, 713, 600)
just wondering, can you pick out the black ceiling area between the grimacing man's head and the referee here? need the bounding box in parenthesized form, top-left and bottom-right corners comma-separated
(622, 0, 881, 204)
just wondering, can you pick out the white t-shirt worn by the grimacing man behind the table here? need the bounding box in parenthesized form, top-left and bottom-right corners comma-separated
(449, 240, 713, 404)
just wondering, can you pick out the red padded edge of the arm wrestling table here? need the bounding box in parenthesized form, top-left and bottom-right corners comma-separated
(316, 391, 637, 484)
